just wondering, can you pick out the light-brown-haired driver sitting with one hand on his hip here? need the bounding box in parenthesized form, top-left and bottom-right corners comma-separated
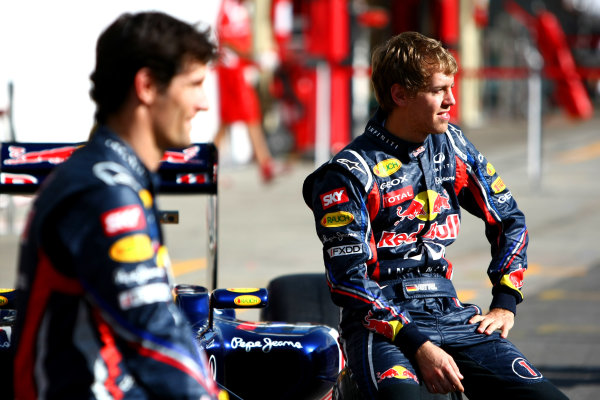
(303, 32, 565, 400)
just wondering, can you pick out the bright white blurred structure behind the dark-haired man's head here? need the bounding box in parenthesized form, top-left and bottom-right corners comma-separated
(0, 0, 220, 142)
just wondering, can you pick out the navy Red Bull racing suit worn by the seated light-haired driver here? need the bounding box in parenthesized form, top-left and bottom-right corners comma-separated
(303, 110, 568, 398)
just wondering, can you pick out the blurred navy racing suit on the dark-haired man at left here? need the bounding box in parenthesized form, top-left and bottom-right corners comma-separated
(15, 127, 217, 400)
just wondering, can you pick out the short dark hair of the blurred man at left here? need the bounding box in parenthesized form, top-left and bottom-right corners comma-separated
(90, 12, 217, 123)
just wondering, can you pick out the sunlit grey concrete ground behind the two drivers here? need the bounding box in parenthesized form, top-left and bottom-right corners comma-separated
(0, 117, 600, 400)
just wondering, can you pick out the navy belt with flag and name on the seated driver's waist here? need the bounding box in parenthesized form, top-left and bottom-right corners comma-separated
(380, 277, 457, 300)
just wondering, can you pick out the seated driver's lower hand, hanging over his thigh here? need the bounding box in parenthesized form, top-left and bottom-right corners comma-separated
(415, 341, 465, 394)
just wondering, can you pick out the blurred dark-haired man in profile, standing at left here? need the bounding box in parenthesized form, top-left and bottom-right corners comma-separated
(14, 12, 217, 400)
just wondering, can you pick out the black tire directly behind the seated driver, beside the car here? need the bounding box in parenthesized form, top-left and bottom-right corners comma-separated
(260, 273, 339, 329)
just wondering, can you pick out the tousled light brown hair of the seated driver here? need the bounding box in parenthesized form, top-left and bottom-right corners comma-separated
(371, 32, 458, 112)
